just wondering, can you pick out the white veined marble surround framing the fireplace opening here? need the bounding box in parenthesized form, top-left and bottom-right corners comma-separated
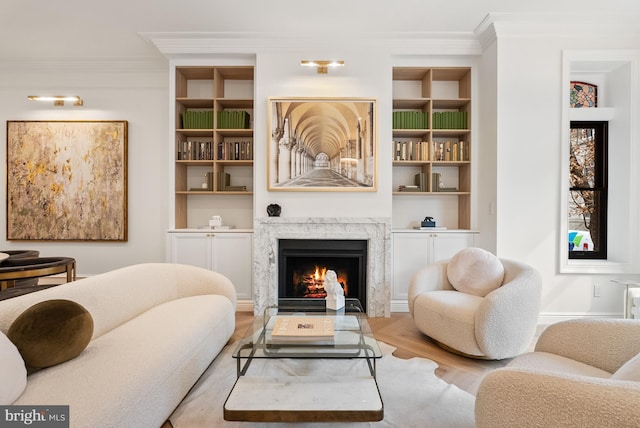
(253, 217, 391, 317)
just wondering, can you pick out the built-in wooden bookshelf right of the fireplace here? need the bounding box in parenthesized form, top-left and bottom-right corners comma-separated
(390, 67, 472, 229)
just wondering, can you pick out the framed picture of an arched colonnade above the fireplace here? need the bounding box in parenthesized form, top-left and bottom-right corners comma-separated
(267, 98, 378, 192)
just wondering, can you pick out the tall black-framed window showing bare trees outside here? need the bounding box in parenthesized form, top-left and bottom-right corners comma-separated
(567, 121, 608, 259)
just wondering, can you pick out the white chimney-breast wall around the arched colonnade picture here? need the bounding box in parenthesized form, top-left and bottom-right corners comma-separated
(254, 48, 391, 217)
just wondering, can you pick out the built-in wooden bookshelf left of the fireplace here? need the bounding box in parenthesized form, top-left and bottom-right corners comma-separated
(174, 66, 254, 229)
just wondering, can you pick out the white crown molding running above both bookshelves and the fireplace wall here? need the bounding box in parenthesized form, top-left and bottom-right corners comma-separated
(140, 32, 480, 58)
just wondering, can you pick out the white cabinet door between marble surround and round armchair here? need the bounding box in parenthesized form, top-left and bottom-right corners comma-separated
(392, 232, 431, 300)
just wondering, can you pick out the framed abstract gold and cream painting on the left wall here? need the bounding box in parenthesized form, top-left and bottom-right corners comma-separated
(6, 120, 128, 241)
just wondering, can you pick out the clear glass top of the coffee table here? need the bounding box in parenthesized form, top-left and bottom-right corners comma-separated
(233, 299, 382, 359)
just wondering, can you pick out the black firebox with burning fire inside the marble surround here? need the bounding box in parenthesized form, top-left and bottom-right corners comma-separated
(278, 239, 367, 311)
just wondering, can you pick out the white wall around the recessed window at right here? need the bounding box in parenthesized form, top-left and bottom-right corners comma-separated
(496, 31, 640, 319)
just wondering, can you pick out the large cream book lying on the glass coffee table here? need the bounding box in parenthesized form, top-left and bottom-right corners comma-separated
(271, 316, 335, 343)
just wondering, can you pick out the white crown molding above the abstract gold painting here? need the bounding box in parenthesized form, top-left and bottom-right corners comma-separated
(0, 56, 168, 73)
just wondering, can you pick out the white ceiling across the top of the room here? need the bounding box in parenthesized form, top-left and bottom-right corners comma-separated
(0, 0, 640, 63)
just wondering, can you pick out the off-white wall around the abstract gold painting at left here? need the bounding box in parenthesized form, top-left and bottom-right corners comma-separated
(0, 61, 169, 276)
